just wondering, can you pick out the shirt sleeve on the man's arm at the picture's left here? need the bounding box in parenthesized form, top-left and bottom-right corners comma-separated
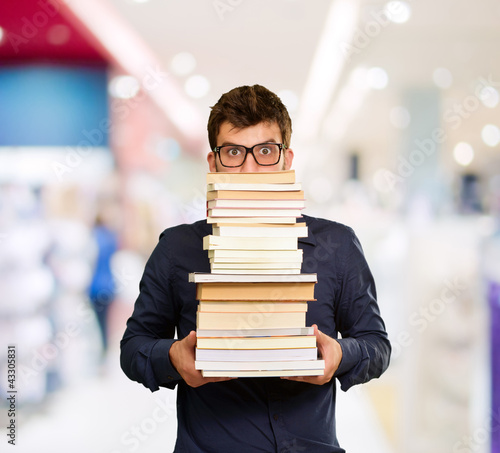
(120, 233, 182, 392)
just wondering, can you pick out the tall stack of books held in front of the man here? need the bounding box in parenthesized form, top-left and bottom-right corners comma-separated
(189, 171, 325, 377)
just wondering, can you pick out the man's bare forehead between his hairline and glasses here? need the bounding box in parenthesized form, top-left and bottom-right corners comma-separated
(217, 121, 282, 146)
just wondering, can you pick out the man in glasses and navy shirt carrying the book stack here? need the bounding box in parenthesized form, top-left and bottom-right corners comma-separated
(121, 85, 391, 453)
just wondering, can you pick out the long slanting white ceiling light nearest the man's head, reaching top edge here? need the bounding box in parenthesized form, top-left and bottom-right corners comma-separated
(295, 0, 360, 140)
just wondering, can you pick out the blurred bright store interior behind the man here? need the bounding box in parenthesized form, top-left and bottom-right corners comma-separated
(0, 0, 500, 453)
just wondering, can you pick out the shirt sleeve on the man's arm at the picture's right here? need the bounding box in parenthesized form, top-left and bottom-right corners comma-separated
(335, 228, 391, 391)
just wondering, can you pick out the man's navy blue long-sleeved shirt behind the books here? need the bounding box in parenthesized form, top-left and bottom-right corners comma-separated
(121, 216, 391, 453)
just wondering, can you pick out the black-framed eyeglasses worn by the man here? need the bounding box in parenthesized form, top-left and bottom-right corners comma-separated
(213, 143, 285, 168)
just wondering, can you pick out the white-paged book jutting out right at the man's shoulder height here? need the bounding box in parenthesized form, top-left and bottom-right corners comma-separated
(212, 223, 308, 238)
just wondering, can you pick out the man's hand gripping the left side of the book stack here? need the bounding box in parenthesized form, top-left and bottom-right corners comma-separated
(169, 330, 234, 387)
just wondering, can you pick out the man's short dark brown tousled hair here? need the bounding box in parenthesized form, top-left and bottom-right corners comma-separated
(207, 85, 292, 149)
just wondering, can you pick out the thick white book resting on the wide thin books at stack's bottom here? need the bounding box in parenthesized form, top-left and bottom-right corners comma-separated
(195, 348, 318, 362)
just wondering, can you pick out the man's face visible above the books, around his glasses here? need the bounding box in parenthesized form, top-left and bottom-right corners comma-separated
(207, 122, 293, 173)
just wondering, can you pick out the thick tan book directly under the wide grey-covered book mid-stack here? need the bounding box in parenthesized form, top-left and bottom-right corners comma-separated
(196, 280, 315, 301)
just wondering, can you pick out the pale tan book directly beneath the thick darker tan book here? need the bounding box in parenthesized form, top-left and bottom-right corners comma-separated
(198, 300, 307, 314)
